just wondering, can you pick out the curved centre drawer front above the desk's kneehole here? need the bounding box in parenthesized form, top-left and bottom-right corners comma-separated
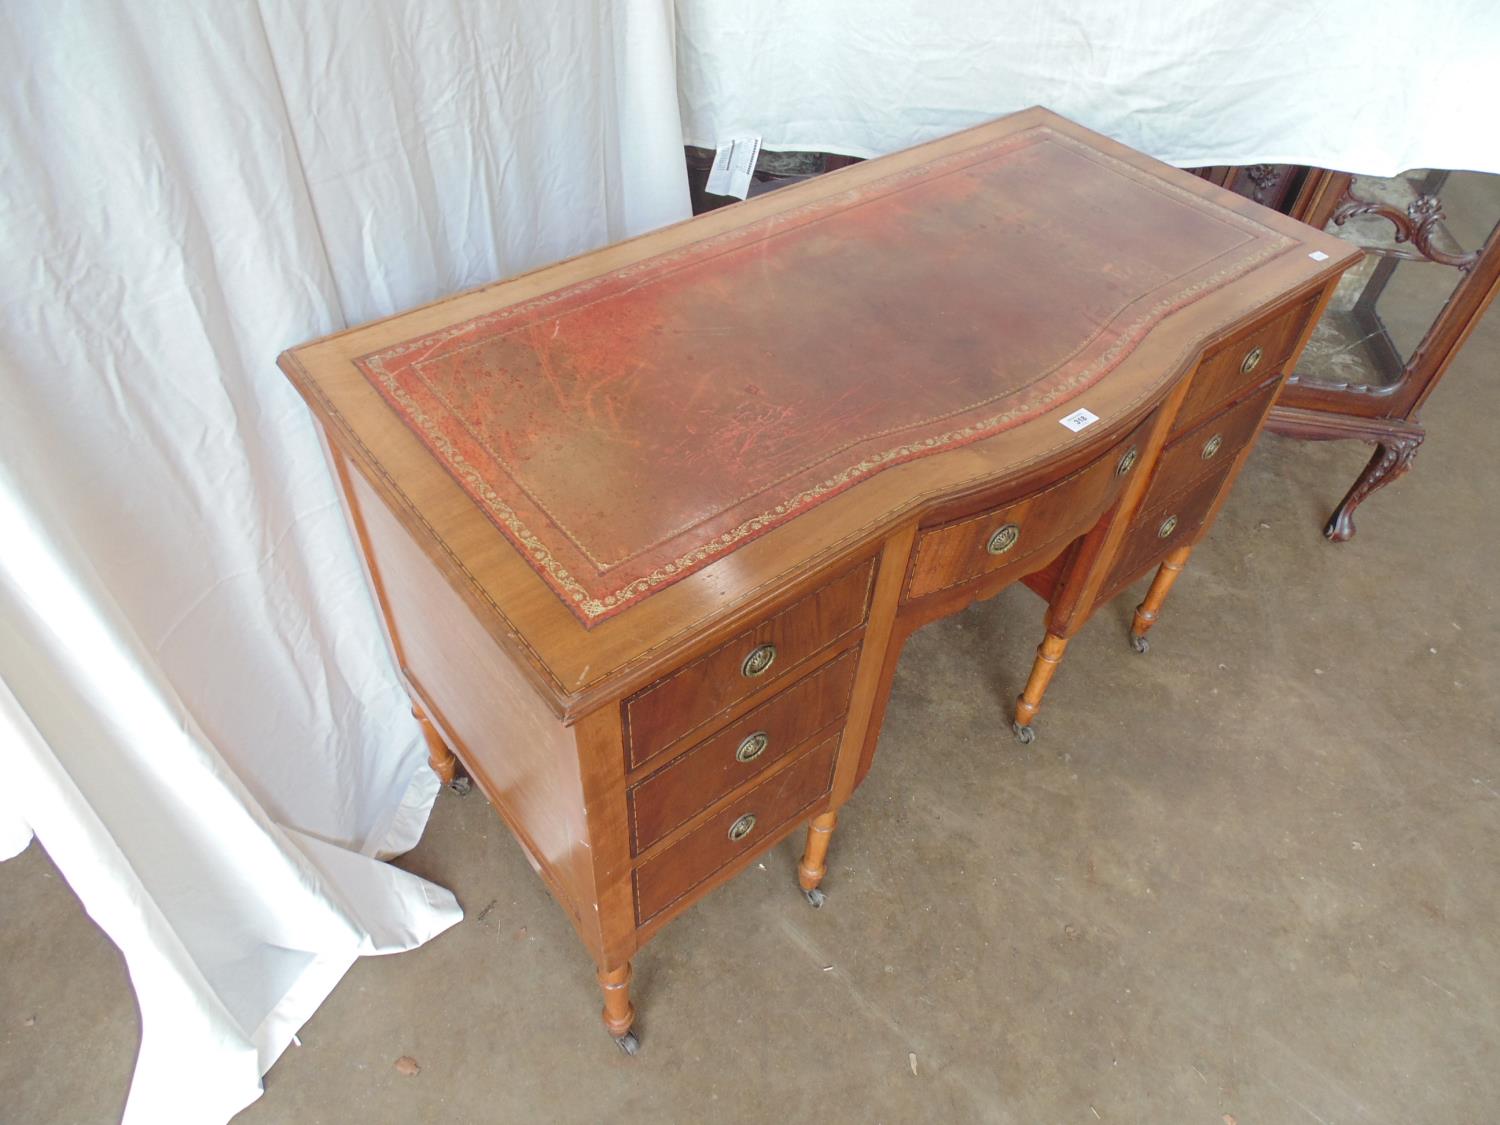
(906, 426, 1146, 599)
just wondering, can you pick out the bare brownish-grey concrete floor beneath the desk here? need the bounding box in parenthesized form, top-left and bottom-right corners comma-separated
(0, 234, 1500, 1125)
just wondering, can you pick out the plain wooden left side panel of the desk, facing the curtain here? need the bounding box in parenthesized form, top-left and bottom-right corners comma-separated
(333, 450, 599, 948)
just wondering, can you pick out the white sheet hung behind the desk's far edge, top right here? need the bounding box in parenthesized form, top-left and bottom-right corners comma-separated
(678, 0, 1500, 176)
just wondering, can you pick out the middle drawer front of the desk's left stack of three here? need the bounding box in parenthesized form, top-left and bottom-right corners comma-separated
(627, 648, 860, 854)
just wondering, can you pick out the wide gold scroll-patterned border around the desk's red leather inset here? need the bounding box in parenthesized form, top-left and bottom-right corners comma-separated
(348, 126, 1295, 627)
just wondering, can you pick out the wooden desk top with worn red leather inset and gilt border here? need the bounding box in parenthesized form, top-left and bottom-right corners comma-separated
(281, 110, 1352, 717)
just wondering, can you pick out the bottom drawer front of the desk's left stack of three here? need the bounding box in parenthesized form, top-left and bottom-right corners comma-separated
(635, 735, 839, 924)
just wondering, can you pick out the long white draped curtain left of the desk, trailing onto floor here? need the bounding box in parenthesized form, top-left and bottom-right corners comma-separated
(0, 0, 687, 1122)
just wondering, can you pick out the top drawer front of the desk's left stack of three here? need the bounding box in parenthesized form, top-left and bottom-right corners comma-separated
(626, 560, 875, 767)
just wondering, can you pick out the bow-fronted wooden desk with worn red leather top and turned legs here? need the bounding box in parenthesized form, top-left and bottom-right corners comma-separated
(281, 110, 1358, 1052)
